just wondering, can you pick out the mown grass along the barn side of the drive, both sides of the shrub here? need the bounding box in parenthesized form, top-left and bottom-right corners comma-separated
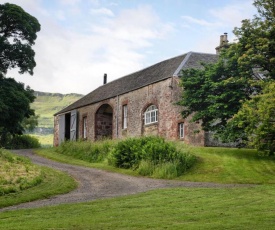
(37, 146, 275, 184)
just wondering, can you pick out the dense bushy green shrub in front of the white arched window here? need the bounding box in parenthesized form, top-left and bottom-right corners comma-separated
(108, 136, 196, 179)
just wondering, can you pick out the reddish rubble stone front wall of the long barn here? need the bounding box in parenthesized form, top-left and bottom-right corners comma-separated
(54, 77, 204, 146)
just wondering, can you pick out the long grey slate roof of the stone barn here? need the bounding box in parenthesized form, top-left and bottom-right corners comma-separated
(55, 52, 218, 115)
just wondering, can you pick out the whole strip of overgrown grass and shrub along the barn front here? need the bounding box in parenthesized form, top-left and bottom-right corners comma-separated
(55, 136, 196, 179)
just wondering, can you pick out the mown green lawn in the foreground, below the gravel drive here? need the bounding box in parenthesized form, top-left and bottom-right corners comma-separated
(0, 186, 275, 230)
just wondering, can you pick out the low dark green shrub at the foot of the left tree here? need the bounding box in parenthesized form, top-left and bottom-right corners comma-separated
(3, 135, 41, 149)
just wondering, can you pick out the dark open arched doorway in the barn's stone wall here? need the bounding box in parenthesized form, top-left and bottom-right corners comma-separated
(95, 104, 113, 140)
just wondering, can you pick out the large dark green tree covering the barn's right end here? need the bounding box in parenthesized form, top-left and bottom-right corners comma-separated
(179, 0, 275, 153)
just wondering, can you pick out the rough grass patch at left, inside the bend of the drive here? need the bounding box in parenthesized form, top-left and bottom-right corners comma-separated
(0, 150, 77, 208)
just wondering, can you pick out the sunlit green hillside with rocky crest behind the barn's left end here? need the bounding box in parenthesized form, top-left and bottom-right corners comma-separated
(31, 91, 83, 133)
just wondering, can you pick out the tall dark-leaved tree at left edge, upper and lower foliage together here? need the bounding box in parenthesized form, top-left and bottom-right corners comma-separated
(0, 3, 40, 146)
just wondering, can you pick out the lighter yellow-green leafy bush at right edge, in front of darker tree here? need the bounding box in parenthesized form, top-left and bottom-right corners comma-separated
(228, 81, 275, 155)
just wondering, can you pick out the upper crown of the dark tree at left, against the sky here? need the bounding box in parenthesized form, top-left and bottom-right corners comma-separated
(0, 3, 40, 77)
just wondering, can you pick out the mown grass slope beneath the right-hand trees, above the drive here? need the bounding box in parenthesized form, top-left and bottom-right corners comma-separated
(180, 147, 275, 184)
